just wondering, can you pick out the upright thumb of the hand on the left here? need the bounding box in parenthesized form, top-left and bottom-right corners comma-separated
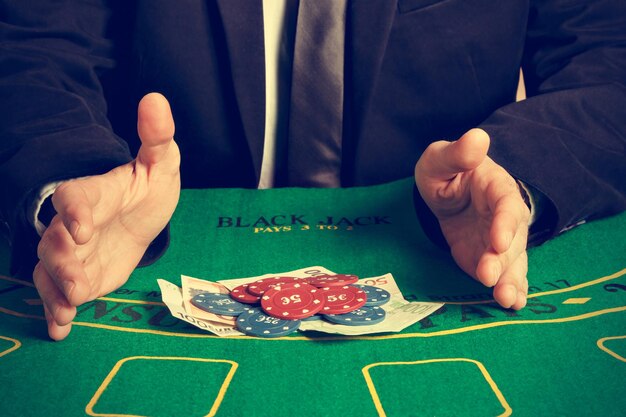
(137, 93, 174, 165)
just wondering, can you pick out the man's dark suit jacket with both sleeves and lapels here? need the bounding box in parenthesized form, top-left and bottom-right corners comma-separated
(0, 0, 626, 275)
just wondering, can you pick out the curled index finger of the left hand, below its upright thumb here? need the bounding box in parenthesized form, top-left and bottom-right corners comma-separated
(52, 180, 100, 245)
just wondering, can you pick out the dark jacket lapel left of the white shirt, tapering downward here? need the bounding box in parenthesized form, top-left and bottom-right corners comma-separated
(217, 0, 265, 181)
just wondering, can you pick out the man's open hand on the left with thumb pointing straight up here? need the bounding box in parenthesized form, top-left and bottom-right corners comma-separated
(33, 93, 180, 340)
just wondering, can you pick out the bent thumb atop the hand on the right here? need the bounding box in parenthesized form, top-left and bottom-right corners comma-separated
(415, 129, 489, 181)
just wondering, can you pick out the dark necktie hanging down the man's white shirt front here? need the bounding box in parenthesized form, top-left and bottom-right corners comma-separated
(287, 0, 347, 187)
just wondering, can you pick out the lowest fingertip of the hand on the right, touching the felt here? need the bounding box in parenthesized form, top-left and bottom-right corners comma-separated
(493, 252, 528, 310)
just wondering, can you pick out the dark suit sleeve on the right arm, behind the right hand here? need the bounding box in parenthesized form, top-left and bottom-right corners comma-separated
(480, 0, 626, 244)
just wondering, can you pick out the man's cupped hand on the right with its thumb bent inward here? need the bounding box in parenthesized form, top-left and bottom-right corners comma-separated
(415, 129, 530, 310)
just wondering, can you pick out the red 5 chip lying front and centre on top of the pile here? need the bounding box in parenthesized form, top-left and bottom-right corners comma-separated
(261, 282, 324, 320)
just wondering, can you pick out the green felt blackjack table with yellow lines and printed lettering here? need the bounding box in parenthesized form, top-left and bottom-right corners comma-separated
(0, 179, 626, 417)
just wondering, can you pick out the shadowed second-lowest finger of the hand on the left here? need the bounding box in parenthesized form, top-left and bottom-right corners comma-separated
(33, 262, 76, 326)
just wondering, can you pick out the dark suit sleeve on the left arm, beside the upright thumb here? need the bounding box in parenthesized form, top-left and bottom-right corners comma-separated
(0, 0, 131, 276)
